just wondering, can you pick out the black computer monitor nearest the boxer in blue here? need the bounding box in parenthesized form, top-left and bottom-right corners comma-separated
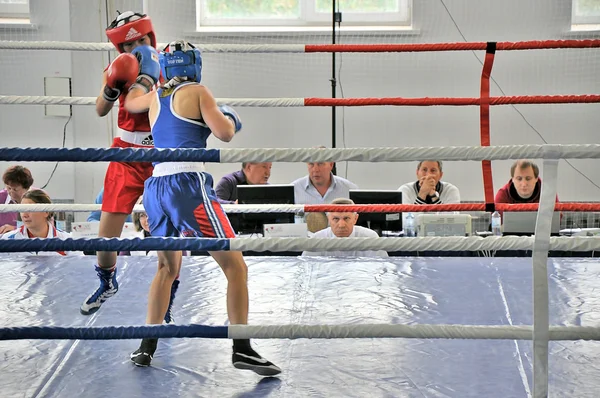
(230, 184, 295, 234)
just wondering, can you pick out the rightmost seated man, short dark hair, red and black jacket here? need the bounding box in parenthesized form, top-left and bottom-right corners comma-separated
(494, 160, 558, 203)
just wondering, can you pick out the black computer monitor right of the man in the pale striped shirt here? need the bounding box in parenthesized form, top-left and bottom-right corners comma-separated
(350, 189, 402, 236)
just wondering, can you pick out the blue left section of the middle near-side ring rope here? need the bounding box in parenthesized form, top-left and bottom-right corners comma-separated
(0, 237, 231, 253)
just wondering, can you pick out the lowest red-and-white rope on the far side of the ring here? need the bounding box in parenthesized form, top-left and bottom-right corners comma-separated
(0, 202, 600, 214)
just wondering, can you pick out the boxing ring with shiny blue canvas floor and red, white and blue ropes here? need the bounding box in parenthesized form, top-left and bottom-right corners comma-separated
(0, 35, 600, 397)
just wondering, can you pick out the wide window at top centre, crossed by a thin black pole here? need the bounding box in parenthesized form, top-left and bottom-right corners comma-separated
(196, 0, 412, 30)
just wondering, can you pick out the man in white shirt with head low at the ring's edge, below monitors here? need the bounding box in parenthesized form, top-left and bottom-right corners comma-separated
(302, 198, 388, 257)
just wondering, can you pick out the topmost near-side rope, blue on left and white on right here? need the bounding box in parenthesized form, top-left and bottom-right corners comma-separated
(0, 144, 600, 163)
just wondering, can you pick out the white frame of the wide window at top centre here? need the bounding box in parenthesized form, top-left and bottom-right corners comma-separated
(196, 0, 413, 31)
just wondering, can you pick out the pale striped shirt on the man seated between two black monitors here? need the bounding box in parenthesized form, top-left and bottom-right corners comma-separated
(292, 173, 358, 205)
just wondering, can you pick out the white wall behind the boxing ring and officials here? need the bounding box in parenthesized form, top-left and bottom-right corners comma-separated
(0, 0, 600, 215)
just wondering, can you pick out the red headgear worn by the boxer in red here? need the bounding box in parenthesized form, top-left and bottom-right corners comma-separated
(106, 11, 156, 53)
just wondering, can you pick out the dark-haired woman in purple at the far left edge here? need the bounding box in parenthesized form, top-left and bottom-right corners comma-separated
(0, 165, 33, 235)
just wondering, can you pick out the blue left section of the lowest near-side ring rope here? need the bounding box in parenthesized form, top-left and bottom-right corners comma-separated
(0, 325, 229, 340)
